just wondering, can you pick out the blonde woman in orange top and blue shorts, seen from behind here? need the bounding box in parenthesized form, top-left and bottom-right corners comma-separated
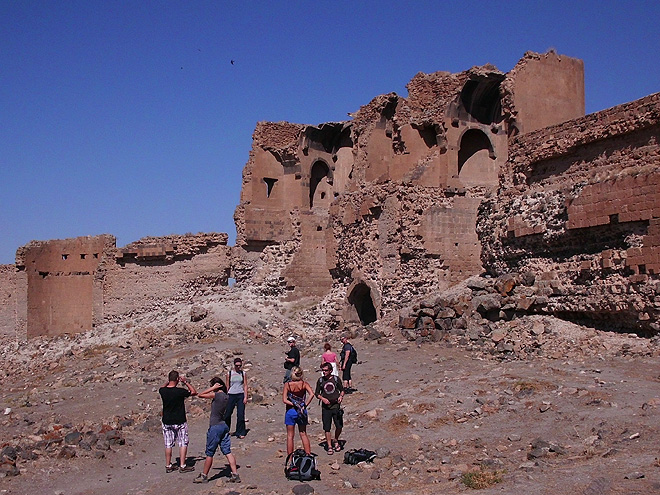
(282, 366, 314, 455)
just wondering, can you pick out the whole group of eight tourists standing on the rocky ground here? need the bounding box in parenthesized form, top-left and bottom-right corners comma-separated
(158, 336, 357, 483)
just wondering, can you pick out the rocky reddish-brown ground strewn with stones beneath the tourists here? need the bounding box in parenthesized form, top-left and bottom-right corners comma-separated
(0, 290, 660, 495)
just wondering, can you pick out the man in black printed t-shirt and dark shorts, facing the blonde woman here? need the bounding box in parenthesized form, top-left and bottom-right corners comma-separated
(314, 363, 344, 455)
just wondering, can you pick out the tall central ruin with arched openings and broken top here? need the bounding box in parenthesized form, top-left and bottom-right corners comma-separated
(234, 53, 584, 324)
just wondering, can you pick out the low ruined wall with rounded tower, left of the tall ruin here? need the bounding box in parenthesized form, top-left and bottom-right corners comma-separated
(9, 233, 231, 337)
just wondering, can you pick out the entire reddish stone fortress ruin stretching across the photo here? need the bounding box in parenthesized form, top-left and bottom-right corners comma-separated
(0, 51, 660, 338)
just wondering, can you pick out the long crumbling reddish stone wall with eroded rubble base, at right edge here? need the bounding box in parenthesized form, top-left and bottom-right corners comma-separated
(477, 94, 660, 334)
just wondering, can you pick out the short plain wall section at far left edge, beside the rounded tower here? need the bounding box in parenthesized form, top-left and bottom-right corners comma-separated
(0, 265, 27, 336)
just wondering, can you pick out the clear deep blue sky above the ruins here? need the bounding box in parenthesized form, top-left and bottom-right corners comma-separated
(0, 0, 660, 263)
